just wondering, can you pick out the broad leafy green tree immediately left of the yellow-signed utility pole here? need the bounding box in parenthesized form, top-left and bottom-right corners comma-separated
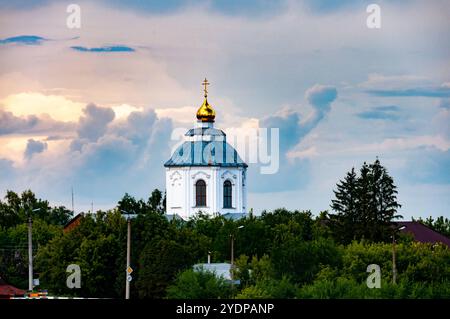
(36, 211, 126, 297)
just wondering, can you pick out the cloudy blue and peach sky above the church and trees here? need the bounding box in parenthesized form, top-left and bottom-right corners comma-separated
(0, 0, 450, 219)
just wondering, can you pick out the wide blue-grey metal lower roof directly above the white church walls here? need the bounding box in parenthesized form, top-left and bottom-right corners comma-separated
(164, 141, 248, 167)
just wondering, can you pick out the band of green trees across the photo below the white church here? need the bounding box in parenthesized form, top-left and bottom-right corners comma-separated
(0, 161, 450, 298)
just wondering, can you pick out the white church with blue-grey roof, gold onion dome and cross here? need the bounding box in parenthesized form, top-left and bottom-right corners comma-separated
(164, 79, 248, 219)
